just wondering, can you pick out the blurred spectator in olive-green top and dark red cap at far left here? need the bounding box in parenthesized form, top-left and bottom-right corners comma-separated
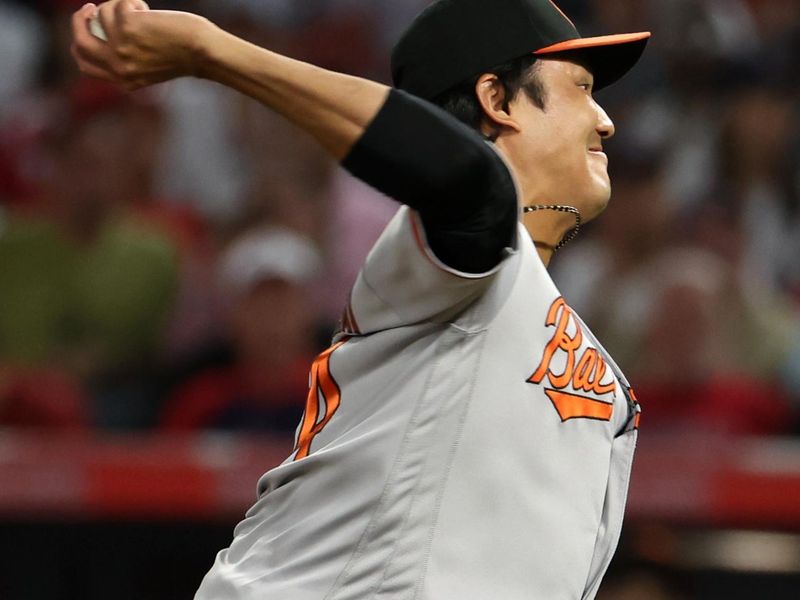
(0, 81, 177, 426)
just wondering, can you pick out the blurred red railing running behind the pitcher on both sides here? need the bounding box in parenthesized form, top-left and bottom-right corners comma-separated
(0, 431, 800, 529)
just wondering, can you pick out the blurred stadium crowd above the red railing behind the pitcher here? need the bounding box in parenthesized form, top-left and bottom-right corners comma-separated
(0, 0, 800, 434)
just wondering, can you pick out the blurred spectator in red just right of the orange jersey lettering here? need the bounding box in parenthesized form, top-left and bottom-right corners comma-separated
(618, 250, 789, 434)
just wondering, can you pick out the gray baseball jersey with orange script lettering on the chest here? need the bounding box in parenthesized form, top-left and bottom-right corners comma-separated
(196, 207, 639, 600)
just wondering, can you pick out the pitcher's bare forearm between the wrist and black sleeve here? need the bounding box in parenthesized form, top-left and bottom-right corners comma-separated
(197, 26, 389, 160)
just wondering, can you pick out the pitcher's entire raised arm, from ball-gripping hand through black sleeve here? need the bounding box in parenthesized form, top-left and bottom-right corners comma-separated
(73, 0, 516, 270)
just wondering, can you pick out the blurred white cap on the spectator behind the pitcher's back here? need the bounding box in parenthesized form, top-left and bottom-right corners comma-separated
(220, 226, 322, 294)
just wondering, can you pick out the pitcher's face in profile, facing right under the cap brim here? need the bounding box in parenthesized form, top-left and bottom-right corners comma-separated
(503, 59, 614, 220)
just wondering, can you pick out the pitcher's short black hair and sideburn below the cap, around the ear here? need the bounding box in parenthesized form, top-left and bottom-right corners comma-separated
(431, 54, 545, 142)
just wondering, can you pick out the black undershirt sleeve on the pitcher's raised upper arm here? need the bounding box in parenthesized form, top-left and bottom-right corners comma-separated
(342, 90, 517, 273)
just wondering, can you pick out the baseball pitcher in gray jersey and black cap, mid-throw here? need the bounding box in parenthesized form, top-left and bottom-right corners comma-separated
(73, 0, 649, 600)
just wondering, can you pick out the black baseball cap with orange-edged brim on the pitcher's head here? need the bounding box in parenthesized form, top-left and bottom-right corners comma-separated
(392, 0, 650, 100)
